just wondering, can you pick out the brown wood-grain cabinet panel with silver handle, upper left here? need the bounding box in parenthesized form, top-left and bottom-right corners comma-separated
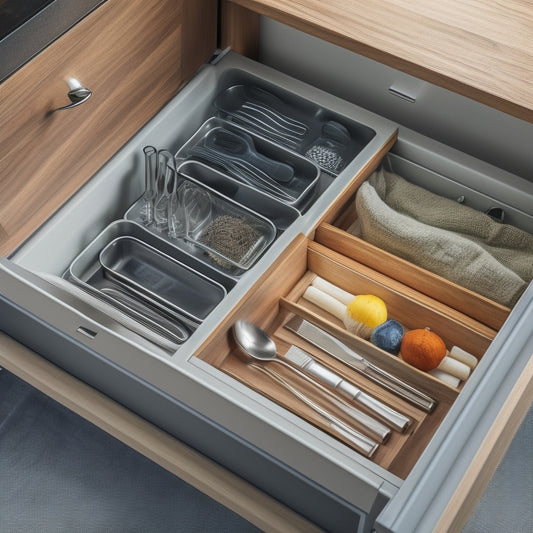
(0, 0, 217, 255)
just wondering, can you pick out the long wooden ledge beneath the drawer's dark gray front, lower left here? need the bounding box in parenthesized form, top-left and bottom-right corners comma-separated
(0, 332, 322, 533)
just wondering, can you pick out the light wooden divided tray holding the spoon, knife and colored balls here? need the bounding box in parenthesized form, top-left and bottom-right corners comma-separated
(196, 235, 495, 478)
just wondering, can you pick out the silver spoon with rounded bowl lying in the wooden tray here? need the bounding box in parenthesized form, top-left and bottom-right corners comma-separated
(232, 320, 394, 442)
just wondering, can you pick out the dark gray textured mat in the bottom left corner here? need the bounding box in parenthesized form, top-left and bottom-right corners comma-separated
(0, 370, 259, 533)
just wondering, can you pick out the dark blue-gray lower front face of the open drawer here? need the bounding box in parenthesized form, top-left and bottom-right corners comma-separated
(0, 297, 364, 532)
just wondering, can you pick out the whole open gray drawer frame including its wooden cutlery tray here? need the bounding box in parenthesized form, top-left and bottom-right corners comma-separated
(0, 8, 533, 531)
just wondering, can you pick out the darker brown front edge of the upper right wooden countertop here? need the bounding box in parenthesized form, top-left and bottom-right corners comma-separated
(225, 0, 533, 122)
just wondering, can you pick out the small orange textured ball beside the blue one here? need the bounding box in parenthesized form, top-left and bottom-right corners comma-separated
(400, 329, 446, 372)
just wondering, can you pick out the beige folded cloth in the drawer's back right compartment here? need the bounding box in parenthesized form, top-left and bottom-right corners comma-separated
(349, 169, 533, 306)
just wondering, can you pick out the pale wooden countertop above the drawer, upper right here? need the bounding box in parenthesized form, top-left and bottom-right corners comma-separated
(223, 0, 533, 122)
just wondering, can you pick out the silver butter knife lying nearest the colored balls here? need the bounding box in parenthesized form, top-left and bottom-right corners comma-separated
(285, 316, 438, 413)
